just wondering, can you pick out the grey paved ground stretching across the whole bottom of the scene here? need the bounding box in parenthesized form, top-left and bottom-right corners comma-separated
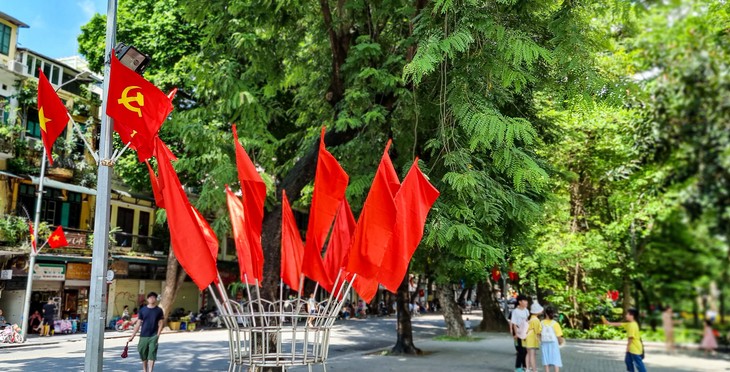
(0, 314, 730, 372)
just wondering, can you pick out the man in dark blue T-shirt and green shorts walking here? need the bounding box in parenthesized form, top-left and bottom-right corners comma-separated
(129, 292, 165, 372)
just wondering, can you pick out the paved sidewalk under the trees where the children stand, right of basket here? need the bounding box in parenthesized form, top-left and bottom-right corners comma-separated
(291, 333, 730, 372)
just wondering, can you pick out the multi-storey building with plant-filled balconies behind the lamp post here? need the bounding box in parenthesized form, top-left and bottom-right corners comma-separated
(0, 11, 203, 323)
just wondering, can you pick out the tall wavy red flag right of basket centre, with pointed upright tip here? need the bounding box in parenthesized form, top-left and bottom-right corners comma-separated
(302, 127, 349, 292)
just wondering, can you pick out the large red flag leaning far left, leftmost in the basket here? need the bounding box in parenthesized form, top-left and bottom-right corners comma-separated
(155, 140, 218, 291)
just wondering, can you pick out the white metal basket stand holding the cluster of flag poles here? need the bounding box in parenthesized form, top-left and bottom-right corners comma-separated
(209, 272, 355, 371)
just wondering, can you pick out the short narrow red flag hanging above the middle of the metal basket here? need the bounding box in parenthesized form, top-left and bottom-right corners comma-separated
(281, 191, 304, 292)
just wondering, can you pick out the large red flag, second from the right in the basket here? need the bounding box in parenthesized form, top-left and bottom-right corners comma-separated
(347, 141, 398, 279)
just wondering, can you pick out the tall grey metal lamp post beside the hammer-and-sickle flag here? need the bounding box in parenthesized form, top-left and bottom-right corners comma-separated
(84, 0, 117, 372)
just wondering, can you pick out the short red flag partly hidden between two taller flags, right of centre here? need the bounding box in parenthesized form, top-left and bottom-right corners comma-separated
(324, 199, 355, 283)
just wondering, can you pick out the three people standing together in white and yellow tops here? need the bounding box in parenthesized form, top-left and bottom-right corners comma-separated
(510, 295, 565, 372)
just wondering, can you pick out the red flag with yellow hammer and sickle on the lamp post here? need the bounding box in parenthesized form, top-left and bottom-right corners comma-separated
(106, 53, 172, 161)
